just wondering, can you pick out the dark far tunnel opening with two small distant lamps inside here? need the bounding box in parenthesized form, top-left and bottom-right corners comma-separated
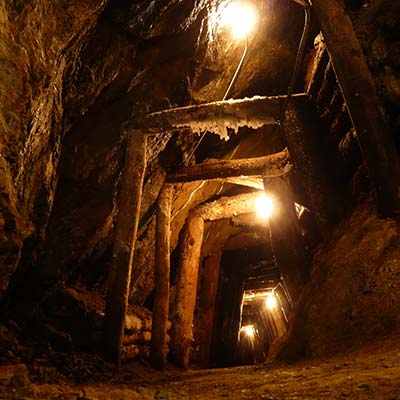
(209, 245, 291, 367)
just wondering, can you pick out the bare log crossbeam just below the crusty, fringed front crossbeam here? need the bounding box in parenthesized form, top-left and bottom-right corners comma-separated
(167, 149, 291, 183)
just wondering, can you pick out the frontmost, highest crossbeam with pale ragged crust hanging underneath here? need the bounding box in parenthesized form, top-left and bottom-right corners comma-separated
(124, 93, 305, 136)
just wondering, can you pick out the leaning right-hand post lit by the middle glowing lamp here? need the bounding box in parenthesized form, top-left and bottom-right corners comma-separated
(264, 178, 308, 300)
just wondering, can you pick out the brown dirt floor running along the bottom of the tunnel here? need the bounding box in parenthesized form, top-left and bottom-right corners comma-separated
(24, 336, 400, 400)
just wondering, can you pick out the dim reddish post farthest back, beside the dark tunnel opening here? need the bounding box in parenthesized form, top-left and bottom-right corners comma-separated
(197, 251, 221, 368)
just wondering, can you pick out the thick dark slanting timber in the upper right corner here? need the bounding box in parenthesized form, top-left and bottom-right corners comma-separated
(313, 0, 400, 216)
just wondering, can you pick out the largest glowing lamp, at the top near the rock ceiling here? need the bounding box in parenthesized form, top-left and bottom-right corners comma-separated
(221, 2, 257, 39)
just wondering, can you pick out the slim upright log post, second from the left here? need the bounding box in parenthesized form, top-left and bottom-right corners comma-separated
(150, 184, 172, 370)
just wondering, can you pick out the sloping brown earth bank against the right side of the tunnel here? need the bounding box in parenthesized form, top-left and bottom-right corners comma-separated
(275, 203, 400, 359)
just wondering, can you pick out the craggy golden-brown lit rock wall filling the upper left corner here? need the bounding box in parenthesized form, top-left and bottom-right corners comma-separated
(0, 0, 105, 291)
